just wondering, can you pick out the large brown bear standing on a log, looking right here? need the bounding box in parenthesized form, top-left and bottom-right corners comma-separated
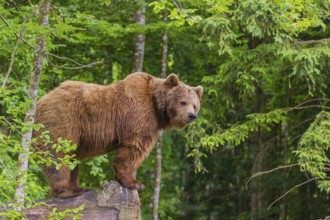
(34, 72, 203, 198)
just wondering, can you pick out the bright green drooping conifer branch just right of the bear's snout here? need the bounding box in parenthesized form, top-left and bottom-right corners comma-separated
(186, 109, 286, 172)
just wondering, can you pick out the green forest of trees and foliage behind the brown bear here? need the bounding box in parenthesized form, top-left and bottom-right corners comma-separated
(0, 0, 330, 220)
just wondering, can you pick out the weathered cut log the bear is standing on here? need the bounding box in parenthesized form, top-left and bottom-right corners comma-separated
(0, 181, 141, 220)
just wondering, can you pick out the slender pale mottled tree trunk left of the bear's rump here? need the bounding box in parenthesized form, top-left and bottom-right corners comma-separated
(14, 0, 50, 205)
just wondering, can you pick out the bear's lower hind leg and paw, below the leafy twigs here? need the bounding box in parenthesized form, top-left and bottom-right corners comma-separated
(44, 165, 82, 199)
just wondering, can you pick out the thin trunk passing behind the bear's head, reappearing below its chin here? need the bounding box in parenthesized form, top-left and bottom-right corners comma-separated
(152, 14, 168, 220)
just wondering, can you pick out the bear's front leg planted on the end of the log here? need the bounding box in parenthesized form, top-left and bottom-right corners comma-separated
(114, 145, 148, 190)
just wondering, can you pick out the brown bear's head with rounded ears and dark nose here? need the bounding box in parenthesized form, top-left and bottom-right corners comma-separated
(155, 74, 203, 129)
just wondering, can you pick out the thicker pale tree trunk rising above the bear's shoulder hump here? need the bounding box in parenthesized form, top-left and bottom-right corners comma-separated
(132, 0, 146, 73)
